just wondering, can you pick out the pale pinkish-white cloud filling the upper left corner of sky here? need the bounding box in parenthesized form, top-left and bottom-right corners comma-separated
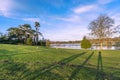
(0, 0, 26, 18)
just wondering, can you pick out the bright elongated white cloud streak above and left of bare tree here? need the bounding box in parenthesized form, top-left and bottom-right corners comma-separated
(73, 5, 97, 14)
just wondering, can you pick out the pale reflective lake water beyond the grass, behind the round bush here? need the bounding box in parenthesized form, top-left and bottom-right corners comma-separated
(51, 44, 120, 50)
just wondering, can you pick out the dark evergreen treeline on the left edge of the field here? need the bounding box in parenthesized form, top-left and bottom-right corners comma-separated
(0, 22, 50, 46)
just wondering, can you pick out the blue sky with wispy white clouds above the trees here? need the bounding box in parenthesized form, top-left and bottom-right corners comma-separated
(0, 0, 120, 41)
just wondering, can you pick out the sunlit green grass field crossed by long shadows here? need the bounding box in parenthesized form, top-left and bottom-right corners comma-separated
(0, 44, 120, 80)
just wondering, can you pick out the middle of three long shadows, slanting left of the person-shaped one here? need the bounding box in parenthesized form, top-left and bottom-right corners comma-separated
(69, 52, 94, 80)
